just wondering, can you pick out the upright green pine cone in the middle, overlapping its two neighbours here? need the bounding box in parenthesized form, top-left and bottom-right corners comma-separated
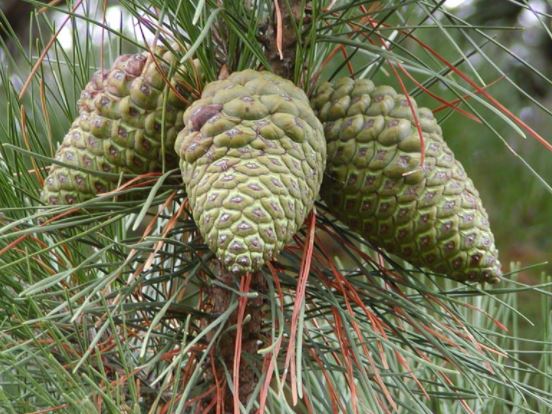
(175, 70, 326, 274)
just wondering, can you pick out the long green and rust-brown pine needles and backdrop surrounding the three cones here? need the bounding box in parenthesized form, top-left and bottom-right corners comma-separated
(0, 0, 552, 413)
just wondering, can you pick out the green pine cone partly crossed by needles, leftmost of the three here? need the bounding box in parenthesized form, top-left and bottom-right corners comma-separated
(41, 48, 192, 205)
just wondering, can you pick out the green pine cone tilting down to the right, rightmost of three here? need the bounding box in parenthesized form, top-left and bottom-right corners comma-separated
(311, 78, 501, 282)
